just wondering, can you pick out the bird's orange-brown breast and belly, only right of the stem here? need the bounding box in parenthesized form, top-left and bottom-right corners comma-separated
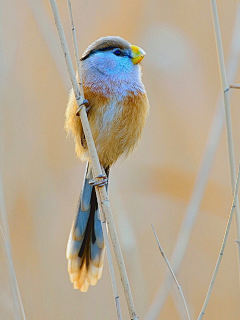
(85, 84, 147, 166)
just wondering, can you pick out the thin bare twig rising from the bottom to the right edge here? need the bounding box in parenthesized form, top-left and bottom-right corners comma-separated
(198, 164, 240, 320)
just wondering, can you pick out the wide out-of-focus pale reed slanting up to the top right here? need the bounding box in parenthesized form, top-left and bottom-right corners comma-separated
(144, 3, 240, 320)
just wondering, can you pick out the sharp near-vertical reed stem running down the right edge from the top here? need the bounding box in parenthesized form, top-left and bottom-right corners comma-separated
(211, 0, 240, 266)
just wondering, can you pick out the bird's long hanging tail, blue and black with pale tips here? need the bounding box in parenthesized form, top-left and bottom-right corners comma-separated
(66, 164, 109, 292)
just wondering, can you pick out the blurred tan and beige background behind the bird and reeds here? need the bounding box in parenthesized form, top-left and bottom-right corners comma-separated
(0, 0, 240, 320)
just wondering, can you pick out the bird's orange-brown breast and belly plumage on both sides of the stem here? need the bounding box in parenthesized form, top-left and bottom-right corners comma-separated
(65, 87, 149, 167)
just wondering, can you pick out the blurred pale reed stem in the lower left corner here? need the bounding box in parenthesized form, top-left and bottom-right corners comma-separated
(0, 172, 26, 320)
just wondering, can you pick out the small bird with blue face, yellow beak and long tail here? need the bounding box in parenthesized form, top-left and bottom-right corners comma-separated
(65, 36, 149, 292)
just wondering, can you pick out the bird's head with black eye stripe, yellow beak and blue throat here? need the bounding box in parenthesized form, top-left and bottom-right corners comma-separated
(81, 36, 146, 95)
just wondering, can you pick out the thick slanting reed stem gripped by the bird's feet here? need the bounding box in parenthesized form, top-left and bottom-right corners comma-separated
(49, 0, 138, 320)
